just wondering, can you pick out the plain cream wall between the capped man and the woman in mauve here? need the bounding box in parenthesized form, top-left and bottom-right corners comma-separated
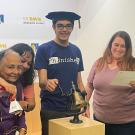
(77, 0, 135, 82)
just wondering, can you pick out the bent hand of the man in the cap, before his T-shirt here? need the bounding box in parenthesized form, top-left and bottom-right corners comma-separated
(46, 79, 59, 92)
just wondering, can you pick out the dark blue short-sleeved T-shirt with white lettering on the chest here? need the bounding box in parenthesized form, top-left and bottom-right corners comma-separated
(35, 41, 83, 111)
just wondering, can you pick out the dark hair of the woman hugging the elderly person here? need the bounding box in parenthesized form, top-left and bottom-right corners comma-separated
(10, 43, 35, 87)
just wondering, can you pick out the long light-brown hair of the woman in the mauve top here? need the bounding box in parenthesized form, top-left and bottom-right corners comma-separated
(97, 31, 135, 71)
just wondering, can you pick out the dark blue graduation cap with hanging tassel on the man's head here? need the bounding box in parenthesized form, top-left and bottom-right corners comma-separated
(46, 11, 81, 28)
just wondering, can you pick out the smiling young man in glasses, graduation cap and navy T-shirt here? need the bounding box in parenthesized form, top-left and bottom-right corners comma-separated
(35, 11, 84, 135)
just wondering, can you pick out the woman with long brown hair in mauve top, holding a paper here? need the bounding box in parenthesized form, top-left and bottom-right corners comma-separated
(85, 31, 135, 135)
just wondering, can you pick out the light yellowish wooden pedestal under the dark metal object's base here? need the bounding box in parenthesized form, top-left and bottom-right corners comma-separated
(49, 116, 105, 135)
